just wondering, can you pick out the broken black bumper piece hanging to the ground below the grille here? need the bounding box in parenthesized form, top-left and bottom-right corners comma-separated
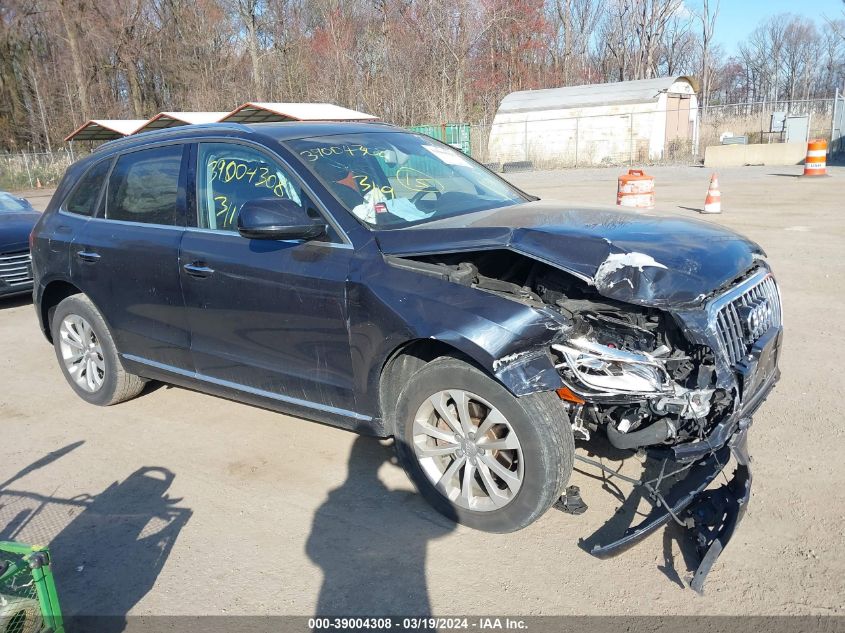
(590, 418, 751, 593)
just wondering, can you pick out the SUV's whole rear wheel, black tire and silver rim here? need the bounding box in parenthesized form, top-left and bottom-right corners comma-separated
(50, 294, 146, 406)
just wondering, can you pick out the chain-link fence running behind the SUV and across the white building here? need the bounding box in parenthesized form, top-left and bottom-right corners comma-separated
(0, 95, 845, 191)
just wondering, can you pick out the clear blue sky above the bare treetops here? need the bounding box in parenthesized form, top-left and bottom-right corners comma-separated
(712, 0, 845, 55)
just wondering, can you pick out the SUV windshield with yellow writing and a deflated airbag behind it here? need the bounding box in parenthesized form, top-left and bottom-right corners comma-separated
(288, 132, 526, 229)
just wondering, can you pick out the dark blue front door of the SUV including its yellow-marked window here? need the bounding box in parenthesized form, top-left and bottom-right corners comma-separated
(180, 143, 355, 413)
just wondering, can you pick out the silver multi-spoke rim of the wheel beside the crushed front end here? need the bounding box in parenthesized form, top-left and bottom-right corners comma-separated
(412, 389, 525, 512)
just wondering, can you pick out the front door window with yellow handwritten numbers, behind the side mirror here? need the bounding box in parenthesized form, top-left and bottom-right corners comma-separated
(197, 143, 340, 242)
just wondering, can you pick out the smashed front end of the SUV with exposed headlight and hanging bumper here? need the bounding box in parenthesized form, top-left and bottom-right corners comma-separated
(386, 250, 782, 591)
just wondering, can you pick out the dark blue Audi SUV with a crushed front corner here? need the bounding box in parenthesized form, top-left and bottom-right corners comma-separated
(32, 123, 782, 588)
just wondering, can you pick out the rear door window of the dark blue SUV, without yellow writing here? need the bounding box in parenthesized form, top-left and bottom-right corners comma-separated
(106, 145, 183, 225)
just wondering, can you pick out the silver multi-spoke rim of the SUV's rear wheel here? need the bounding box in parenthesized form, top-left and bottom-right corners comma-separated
(59, 314, 106, 393)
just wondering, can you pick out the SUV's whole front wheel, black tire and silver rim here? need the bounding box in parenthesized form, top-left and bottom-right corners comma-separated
(395, 358, 575, 532)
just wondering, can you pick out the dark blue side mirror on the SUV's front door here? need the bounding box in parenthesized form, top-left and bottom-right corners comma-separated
(238, 198, 328, 240)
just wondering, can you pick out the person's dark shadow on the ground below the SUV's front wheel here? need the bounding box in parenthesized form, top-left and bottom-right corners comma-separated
(306, 436, 454, 616)
